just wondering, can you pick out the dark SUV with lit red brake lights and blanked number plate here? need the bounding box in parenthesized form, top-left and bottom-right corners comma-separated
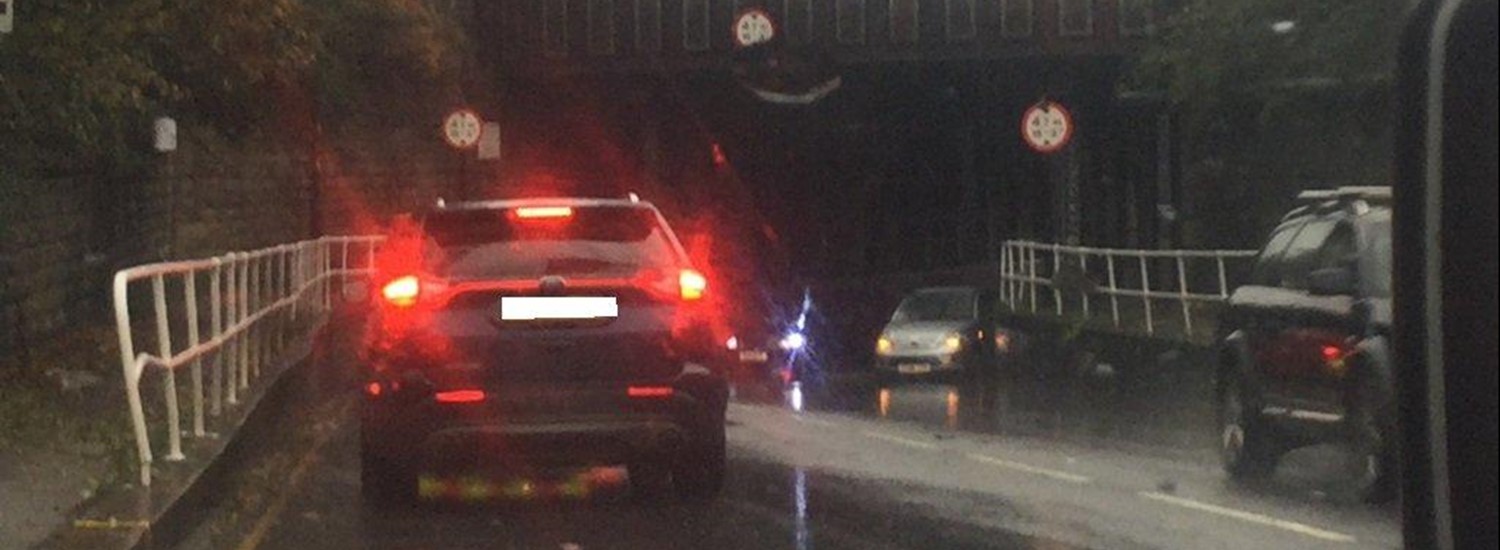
(360, 198, 728, 502)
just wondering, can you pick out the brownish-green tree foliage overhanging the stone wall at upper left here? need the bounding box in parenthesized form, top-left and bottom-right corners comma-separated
(0, 0, 465, 169)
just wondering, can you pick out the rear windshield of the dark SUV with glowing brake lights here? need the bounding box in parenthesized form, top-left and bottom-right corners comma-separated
(423, 207, 677, 280)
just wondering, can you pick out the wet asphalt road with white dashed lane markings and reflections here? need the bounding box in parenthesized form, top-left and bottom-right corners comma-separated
(179, 326, 1400, 550)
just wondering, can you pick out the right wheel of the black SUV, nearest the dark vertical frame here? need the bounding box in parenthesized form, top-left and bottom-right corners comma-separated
(1346, 376, 1395, 502)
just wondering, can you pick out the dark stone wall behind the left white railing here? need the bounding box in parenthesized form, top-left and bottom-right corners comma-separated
(0, 121, 468, 368)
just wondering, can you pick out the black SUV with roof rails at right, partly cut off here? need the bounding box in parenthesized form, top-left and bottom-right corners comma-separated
(1215, 187, 1395, 501)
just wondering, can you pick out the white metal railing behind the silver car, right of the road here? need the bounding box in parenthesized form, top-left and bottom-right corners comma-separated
(1001, 241, 1257, 337)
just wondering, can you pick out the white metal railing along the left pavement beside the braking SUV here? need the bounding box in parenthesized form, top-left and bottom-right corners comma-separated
(114, 237, 383, 486)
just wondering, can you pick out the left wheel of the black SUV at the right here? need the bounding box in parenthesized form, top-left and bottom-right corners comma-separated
(1218, 378, 1280, 481)
